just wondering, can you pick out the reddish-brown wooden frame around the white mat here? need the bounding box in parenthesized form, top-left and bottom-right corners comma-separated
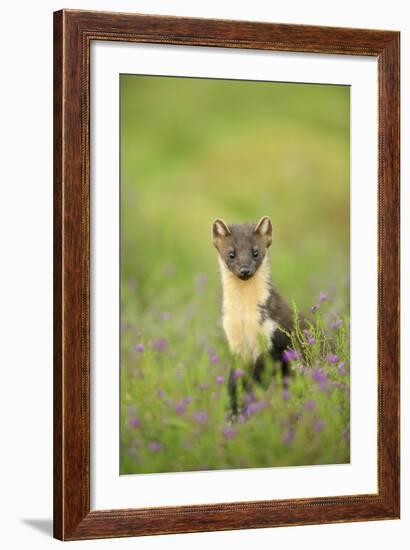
(54, 10, 400, 540)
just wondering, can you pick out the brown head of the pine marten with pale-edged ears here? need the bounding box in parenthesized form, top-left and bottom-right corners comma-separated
(212, 216, 272, 281)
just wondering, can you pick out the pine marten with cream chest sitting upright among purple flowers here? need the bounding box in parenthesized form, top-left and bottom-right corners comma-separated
(212, 216, 294, 414)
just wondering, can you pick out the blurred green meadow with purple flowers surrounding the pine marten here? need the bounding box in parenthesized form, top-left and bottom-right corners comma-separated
(121, 76, 350, 473)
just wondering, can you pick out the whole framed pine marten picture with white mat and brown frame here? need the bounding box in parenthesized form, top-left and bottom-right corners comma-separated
(54, 10, 400, 540)
